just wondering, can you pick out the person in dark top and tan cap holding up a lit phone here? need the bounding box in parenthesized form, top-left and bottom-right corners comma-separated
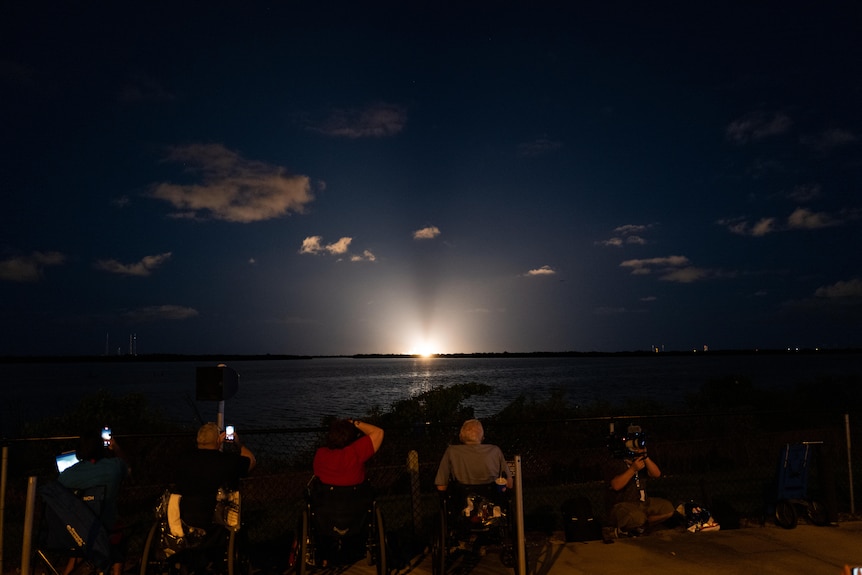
(172, 423, 256, 545)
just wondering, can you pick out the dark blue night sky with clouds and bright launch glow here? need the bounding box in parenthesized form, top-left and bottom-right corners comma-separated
(0, 1, 862, 355)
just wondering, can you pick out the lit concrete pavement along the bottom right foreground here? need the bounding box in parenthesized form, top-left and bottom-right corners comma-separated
(280, 521, 862, 575)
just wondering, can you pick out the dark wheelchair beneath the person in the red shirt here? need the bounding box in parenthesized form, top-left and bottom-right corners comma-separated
(288, 478, 388, 575)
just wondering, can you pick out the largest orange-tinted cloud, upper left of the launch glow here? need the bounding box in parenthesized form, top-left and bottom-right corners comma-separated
(150, 144, 314, 223)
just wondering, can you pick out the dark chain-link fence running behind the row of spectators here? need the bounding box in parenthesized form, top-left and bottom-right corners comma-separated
(4, 412, 862, 566)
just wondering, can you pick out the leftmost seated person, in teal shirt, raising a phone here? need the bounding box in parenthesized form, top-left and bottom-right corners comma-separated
(57, 430, 129, 575)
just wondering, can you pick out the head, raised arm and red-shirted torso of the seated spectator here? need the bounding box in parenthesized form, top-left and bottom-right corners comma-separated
(314, 419, 383, 486)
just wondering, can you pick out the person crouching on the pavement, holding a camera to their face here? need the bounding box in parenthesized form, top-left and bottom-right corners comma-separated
(604, 425, 675, 536)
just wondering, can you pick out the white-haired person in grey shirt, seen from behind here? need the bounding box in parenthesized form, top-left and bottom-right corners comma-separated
(434, 419, 512, 491)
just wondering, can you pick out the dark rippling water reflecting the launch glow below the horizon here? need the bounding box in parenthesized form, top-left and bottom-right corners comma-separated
(0, 354, 862, 435)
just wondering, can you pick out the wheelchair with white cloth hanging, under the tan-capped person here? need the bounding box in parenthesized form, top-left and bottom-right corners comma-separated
(140, 489, 246, 575)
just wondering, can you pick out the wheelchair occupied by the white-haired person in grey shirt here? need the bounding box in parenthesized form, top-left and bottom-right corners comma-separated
(431, 482, 515, 575)
